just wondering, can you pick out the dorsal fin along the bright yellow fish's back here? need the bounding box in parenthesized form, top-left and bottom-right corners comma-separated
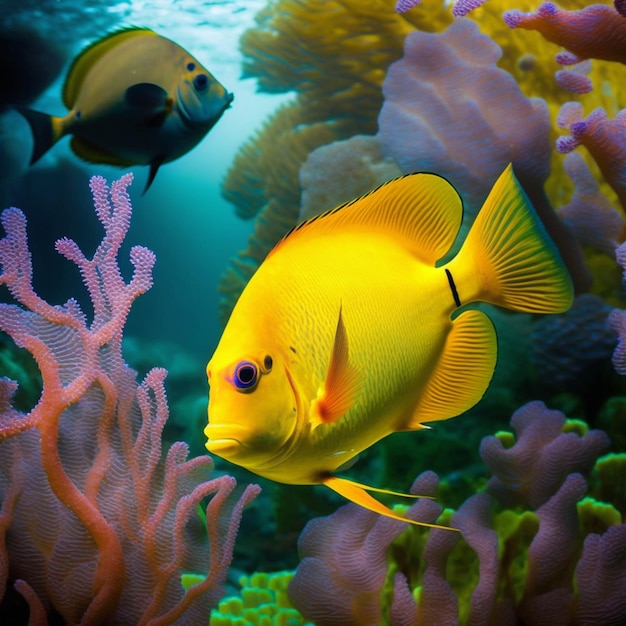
(268, 173, 463, 266)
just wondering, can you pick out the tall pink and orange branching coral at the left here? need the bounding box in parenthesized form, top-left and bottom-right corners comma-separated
(0, 175, 258, 624)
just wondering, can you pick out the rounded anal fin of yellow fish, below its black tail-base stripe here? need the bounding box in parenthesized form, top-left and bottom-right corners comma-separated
(399, 310, 497, 430)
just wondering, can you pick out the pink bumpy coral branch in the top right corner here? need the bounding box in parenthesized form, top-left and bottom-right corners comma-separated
(503, 2, 626, 65)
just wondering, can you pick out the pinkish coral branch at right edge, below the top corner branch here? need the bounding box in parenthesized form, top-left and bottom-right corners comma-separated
(556, 101, 626, 211)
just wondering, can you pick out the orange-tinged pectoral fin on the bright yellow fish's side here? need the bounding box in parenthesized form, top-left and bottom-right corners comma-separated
(309, 307, 360, 428)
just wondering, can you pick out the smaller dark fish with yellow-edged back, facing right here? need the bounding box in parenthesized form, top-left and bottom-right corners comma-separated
(21, 28, 233, 192)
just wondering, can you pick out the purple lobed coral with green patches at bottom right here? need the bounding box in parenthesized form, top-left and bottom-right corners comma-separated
(288, 402, 626, 626)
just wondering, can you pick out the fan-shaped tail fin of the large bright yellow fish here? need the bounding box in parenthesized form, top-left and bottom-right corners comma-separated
(448, 164, 573, 313)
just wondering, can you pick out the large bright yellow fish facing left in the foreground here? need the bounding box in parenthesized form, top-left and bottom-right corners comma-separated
(204, 166, 573, 525)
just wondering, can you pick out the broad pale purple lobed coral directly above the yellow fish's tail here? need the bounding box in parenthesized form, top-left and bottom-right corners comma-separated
(377, 20, 550, 211)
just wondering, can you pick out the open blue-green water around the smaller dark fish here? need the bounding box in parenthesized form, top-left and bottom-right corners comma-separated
(0, 0, 289, 360)
